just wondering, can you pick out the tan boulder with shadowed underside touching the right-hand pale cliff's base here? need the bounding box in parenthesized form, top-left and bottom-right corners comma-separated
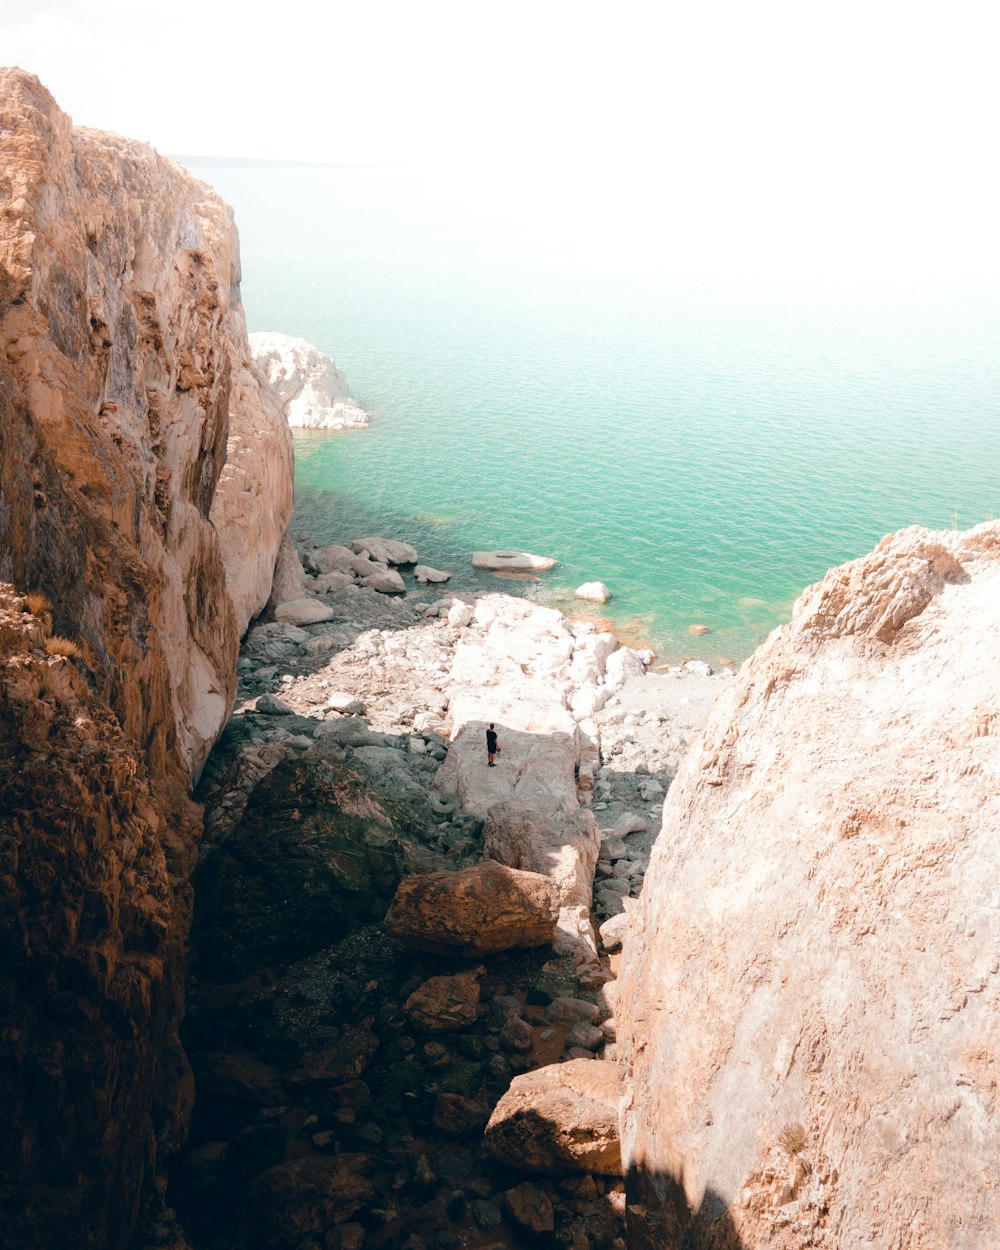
(484, 1059, 621, 1176)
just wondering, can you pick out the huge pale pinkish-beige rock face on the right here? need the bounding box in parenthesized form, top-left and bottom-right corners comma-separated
(618, 523, 1000, 1250)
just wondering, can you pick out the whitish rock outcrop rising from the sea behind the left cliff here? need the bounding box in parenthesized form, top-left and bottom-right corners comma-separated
(250, 333, 368, 430)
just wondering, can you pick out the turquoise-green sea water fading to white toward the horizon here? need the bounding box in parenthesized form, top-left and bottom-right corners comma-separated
(195, 168, 1000, 660)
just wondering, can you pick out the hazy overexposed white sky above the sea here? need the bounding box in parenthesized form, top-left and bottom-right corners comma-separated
(0, 0, 1000, 278)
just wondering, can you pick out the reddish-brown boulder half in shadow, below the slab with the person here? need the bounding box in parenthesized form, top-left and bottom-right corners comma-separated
(385, 861, 559, 958)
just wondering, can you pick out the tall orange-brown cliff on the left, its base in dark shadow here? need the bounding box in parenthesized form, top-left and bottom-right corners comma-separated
(0, 70, 291, 1248)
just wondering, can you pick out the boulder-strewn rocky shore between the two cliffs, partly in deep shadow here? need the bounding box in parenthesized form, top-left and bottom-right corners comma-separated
(172, 539, 731, 1250)
